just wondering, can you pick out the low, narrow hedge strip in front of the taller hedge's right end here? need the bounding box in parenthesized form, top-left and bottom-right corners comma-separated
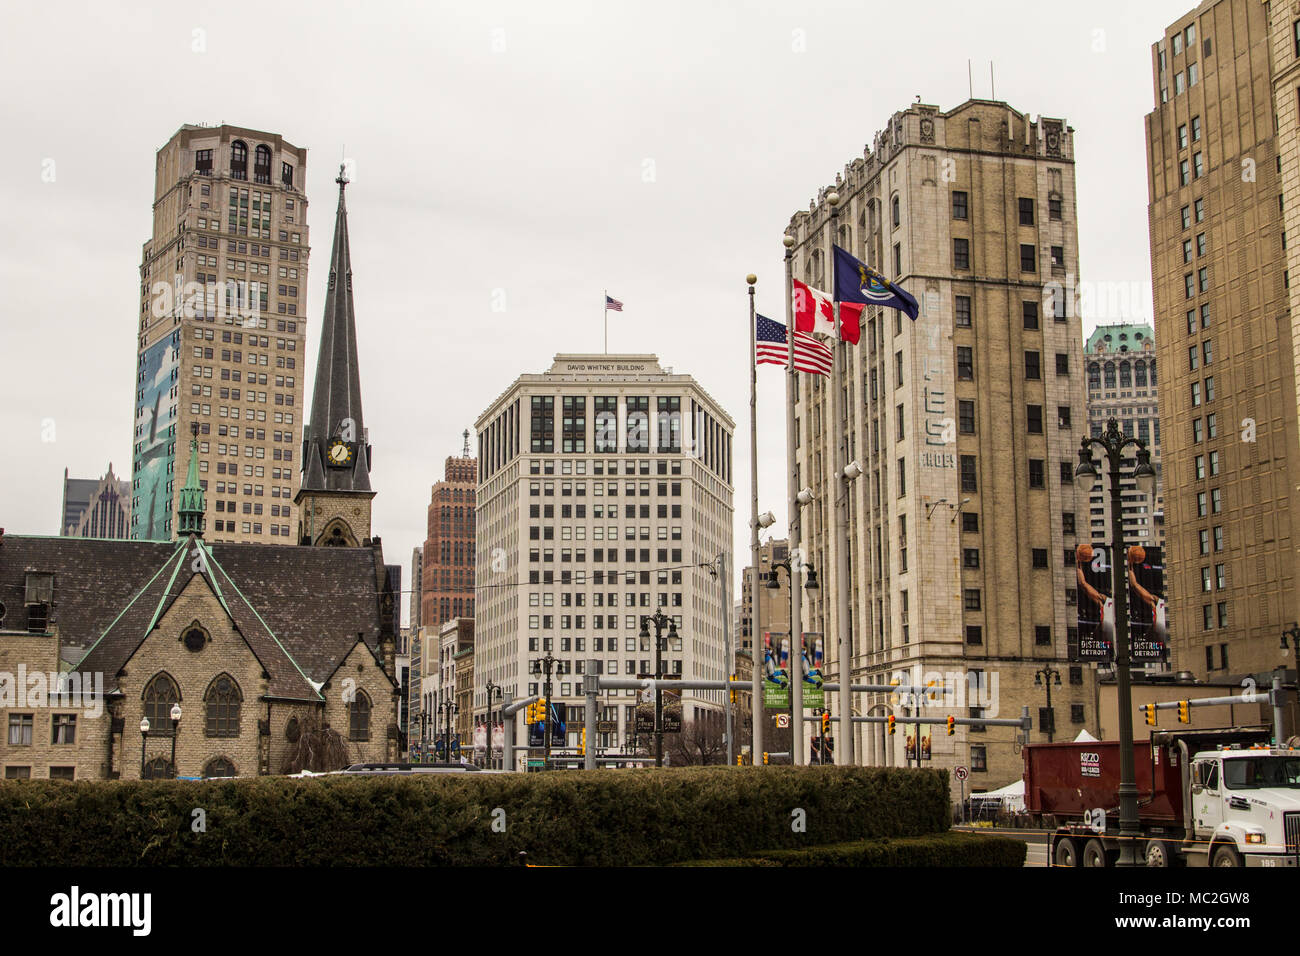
(675, 832, 1027, 866)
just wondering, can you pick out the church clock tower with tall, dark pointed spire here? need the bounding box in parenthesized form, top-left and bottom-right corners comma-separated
(294, 166, 374, 548)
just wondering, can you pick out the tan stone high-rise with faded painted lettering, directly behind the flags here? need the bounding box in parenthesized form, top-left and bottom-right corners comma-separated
(783, 100, 1093, 787)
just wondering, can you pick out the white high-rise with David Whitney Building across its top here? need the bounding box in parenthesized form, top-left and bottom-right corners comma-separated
(473, 355, 733, 764)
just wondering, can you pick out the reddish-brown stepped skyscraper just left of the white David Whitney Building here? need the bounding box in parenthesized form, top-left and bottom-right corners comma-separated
(420, 447, 478, 632)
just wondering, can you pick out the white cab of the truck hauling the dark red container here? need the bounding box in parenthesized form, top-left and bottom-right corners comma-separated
(1183, 747, 1300, 866)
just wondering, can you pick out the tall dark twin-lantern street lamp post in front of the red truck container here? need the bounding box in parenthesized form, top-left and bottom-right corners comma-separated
(1074, 419, 1156, 866)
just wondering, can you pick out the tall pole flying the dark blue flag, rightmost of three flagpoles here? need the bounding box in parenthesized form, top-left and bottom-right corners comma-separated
(827, 193, 852, 766)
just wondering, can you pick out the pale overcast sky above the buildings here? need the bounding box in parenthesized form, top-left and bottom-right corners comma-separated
(0, 0, 1195, 624)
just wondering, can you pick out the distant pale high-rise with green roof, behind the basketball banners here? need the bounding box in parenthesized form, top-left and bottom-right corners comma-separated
(1080, 324, 1165, 548)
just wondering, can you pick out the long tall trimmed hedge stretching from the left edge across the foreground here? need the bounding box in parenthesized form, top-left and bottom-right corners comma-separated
(0, 767, 949, 866)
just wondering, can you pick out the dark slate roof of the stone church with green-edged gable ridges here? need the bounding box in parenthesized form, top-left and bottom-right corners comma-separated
(0, 535, 391, 700)
